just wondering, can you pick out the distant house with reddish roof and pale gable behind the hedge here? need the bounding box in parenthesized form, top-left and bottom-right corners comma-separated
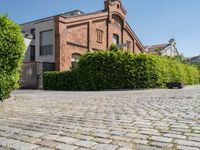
(145, 39, 179, 57)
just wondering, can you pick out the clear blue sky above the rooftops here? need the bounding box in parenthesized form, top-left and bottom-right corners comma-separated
(0, 0, 200, 57)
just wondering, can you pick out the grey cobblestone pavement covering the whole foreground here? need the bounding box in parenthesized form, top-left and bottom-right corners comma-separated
(0, 86, 200, 150)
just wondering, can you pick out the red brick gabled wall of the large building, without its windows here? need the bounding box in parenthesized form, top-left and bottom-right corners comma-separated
(55, 1, 143, 71)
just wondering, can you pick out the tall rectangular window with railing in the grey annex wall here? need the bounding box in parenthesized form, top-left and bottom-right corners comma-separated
(40, 30, 53, 56)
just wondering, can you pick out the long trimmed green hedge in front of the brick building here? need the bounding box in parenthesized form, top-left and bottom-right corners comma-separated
(44, 51, 199, 90)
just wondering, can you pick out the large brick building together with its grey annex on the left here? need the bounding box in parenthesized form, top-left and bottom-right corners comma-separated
(21, 0, 145, 71)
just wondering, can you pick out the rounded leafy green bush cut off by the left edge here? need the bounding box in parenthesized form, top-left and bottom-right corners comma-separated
(0, 15, 25, 100)
